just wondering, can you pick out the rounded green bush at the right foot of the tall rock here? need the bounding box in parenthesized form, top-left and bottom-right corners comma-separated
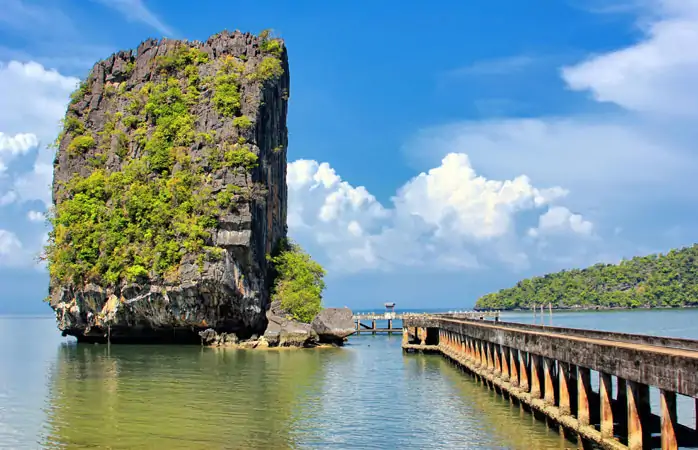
(269, 239, 325, 323)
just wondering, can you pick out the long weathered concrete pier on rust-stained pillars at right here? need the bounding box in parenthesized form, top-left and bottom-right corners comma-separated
(402, 315, 698, 450)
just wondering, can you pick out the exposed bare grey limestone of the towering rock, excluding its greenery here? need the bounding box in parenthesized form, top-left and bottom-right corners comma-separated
(49, 32, 290, 343)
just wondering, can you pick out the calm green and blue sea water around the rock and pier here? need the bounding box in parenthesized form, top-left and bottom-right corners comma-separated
(0, 310, 698, 449)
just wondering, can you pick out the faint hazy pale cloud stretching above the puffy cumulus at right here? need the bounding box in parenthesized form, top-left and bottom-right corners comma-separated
(405, 117, 698, 207)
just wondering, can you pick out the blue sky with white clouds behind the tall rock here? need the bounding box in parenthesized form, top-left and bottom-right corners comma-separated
(0, 0, 698, 313)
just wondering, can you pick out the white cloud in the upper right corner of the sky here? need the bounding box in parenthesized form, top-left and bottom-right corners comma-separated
(562, 0, 698, 116)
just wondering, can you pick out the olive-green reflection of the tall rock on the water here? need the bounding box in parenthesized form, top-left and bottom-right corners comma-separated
(43, 344, 332, 449)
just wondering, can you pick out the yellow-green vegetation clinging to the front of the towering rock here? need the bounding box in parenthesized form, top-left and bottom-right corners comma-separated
(45, 41, 278, 288)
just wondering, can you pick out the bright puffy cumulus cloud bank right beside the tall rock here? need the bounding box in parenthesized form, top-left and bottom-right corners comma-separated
(287, 153, 589, 272)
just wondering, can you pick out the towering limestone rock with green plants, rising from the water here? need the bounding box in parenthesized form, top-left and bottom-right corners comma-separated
(46, 32, 289, 342)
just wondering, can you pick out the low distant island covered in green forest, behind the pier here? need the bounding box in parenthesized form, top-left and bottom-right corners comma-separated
(475, 245, 698, 310)
